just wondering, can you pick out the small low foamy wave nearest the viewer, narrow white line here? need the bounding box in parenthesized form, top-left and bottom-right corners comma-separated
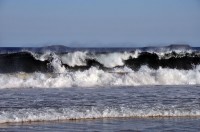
(0, 106, 200, 123)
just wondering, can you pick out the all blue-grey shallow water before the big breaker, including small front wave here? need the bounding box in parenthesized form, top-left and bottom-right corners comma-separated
(0, 85, 200, 131)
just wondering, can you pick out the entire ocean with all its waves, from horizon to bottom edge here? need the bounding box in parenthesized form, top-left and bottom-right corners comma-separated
(0, 45, 200, 132)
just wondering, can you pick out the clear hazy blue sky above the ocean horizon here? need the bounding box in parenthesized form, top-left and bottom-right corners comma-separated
(0, 0, 200, 47)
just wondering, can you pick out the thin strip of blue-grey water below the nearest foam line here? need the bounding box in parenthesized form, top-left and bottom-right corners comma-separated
(0, 118, 200, 132)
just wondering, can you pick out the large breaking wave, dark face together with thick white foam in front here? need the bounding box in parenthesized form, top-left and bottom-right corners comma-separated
(0, 44, 200, 88)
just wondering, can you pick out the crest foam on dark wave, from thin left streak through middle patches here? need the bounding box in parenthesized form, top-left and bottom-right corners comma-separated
(30, 51, 139, 68)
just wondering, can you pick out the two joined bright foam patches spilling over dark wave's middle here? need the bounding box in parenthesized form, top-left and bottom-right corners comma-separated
(61, 51, 138, 68)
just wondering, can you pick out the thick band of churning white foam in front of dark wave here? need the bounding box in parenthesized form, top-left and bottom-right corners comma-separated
(0, 66, 200, 89)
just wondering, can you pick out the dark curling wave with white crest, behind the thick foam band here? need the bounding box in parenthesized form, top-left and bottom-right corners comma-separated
(0, 51, 200, 73)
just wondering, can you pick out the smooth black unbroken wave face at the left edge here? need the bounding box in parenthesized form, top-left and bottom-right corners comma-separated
(0, 52, 51, 73)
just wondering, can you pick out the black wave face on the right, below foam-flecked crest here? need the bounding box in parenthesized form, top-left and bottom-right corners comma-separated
(125, 52, 200, 70)
